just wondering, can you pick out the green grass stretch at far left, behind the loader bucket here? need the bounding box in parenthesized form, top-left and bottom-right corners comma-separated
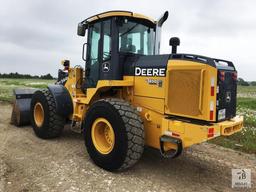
(0, 79, 54, 102)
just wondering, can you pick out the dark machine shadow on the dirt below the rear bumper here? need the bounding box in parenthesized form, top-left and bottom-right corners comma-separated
(134, 147, 227, 183)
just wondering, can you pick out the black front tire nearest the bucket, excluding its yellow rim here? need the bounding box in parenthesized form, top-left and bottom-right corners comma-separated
(30, 89, 65, 139)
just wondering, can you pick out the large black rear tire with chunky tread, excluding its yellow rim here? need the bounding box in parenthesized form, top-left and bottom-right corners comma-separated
(84, 99, 144, 171)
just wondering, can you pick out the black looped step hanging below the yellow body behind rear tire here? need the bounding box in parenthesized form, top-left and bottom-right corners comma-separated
(160, 135, 182, 158)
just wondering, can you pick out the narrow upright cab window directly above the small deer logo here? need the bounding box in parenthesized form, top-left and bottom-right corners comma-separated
(103, 20, 111, 62)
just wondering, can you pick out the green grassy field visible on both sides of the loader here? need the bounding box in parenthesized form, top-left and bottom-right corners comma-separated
(0, 79, 256, 153)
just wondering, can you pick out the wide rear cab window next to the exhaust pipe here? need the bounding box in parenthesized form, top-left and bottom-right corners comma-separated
(119, 20, 155, 55)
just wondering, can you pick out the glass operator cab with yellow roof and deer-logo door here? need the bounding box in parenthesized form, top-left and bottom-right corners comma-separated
(77, 11, 168, 89)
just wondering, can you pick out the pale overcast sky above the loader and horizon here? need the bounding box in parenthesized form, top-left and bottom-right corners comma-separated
(0, 0, 256, 81)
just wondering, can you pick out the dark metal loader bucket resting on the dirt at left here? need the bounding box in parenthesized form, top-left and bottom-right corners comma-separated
(11, 88, 37, 127)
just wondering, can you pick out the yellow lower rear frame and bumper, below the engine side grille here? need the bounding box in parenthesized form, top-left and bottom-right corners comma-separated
(133, 96, 243, 149)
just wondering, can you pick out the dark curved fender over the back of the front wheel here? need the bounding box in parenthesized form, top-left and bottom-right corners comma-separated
(47, 85, 73, 118)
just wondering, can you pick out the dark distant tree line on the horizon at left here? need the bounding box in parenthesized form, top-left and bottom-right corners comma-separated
(0, 72, 54, 79)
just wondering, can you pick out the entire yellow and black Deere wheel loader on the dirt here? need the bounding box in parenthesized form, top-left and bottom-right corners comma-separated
(12, 11, 243, 171)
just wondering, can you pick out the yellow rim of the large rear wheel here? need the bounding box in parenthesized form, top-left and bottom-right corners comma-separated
(91, 118, 115, 154)
